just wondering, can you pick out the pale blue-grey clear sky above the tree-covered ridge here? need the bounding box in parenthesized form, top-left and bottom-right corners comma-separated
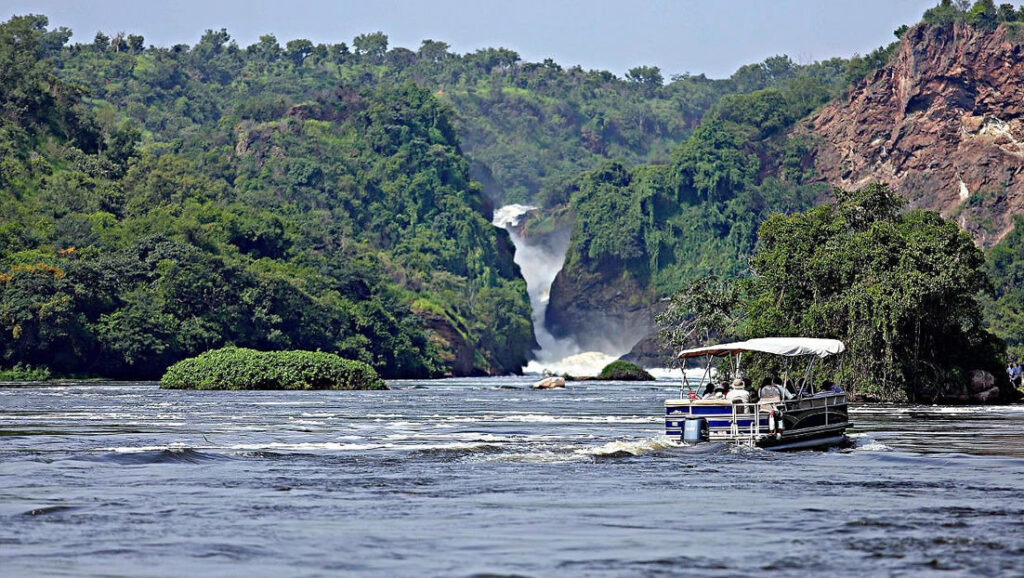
(0, 0, 938, 78)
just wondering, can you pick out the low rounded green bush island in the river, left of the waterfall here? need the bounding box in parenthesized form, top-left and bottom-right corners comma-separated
(160, 347, 387, 389)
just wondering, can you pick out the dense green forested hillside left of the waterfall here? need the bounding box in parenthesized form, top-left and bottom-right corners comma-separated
(0, 16, 534, 377)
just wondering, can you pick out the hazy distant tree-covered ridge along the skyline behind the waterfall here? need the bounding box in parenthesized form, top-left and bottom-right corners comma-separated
(46, 22, 864, 206)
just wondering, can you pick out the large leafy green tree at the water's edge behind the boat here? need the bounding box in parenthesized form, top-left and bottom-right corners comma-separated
(744, 184, 1004, 402)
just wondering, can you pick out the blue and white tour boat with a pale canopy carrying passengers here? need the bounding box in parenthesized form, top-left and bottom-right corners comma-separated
(665, 337, 853, 450)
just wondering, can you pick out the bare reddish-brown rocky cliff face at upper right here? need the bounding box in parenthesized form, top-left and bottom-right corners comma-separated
(801, 24, 1024, 247)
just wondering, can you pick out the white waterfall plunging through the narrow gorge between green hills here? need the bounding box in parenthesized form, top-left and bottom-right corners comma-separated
(493, 205, 626, 376)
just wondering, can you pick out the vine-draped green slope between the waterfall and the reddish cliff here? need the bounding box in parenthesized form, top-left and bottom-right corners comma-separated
(565, 68, 842, 303)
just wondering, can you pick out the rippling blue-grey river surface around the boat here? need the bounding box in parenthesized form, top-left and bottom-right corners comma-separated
(0, 378, 1024, 577)
